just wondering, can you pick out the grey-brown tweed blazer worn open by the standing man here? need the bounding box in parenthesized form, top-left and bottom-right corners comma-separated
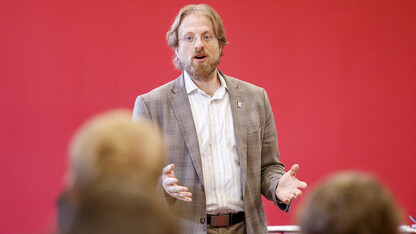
(133, 70, 289, 234)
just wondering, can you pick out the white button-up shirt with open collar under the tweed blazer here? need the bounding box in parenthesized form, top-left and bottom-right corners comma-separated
(184, 71, 244, 214)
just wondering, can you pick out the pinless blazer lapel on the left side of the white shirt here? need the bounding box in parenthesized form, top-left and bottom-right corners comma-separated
(169, 73, 204, 184)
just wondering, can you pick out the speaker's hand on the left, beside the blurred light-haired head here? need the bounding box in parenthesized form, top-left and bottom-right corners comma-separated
(162, 164, 192, 202)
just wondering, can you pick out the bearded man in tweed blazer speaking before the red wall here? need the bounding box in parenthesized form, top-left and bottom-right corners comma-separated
(133, 4, 306, 233)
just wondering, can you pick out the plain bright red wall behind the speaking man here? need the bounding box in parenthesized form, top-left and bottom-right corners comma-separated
(0, 0, 416, 233)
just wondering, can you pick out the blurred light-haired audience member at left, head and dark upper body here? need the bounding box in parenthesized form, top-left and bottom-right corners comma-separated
(61, 110, 176, 234)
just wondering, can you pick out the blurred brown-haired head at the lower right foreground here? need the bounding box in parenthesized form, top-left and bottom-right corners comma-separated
(299, 172, 400, 234)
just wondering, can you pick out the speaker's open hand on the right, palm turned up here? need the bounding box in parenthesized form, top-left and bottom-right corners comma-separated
(276, 164, 307, 204)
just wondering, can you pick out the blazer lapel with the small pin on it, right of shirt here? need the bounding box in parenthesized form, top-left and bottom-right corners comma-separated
(221, 72, 247, 196)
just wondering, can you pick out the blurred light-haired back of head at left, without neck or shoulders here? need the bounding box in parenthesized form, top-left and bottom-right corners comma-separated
(69, 110, 164, 192)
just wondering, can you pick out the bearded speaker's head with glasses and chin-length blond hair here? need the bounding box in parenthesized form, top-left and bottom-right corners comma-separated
(166, 4, 227, 78)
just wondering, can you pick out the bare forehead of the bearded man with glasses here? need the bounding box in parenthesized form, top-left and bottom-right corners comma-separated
(178, 13, 214, 35)
